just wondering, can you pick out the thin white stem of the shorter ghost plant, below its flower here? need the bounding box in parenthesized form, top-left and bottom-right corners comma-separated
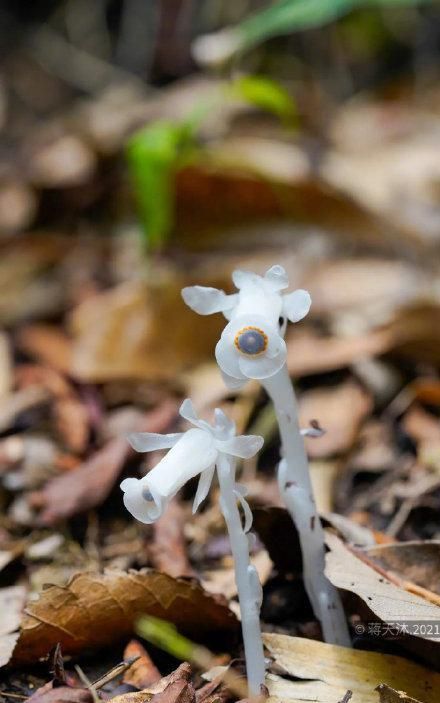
(217, 454, 265, 696)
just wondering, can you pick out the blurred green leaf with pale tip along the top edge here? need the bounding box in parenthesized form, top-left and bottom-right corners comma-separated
(194, 0, 437, 63)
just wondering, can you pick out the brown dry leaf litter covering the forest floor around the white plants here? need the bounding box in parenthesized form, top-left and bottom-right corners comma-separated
(0, 15, 440, 703)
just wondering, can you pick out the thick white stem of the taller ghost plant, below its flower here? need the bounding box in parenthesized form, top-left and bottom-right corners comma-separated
(262, 364, 351, 647)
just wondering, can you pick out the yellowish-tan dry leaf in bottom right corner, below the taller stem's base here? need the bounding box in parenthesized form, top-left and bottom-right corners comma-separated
(263, 634, 440, 703)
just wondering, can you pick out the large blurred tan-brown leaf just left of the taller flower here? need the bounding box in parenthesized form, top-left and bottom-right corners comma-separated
(71, 276, 223, 382)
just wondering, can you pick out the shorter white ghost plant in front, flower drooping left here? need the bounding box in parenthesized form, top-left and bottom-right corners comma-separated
(121, 399, 265, 695)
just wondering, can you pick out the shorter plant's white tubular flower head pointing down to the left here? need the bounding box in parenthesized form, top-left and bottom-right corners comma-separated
(121, 399, 263, 524)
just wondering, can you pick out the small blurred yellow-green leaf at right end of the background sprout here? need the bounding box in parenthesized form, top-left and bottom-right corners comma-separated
(230, 76, 296, 125)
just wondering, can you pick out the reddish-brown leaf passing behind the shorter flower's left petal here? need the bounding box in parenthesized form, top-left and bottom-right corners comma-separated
(29, 401, 176, 525)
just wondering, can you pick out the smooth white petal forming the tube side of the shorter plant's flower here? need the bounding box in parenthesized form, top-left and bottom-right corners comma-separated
(145, 428, 218, 498)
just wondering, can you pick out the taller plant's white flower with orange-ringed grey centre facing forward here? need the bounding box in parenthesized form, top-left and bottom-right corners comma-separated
(182, 266, 311, 388)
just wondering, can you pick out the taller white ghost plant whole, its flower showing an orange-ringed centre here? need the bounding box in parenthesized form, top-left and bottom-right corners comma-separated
(182, 266, 350, 646)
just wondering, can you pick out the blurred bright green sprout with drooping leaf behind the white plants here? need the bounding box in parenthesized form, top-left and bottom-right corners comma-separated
(126, 76, 296, 251)
